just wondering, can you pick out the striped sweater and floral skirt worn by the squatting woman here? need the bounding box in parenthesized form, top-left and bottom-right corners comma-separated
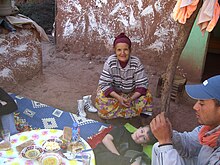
(95, 54, 152, 119)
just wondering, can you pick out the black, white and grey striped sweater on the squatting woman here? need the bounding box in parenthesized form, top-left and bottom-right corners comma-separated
(99, 54, 148, 93)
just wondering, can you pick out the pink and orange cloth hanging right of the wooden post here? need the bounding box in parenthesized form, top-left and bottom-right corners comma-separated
(197, 0, 220, 36)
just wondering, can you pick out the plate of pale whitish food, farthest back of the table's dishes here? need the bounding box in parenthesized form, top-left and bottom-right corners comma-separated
(42, 139, 63, 152)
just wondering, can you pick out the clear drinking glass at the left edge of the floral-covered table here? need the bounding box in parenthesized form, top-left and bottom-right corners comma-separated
(0, 130, 11, 151)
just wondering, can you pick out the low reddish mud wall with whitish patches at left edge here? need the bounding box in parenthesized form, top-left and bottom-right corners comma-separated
(0, 26, 42, 86)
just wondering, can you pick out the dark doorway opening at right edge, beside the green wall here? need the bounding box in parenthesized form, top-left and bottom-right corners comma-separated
(202, 21, 220, 81)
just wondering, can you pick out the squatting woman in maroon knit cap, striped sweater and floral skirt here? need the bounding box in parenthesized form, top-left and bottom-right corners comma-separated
(95, 33, 152, 119)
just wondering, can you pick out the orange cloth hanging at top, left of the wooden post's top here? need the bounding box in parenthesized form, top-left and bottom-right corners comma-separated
(172, 0, 199, 24)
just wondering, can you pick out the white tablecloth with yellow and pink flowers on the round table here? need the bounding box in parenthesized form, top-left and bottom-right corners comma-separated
(0, 129, 95, 165)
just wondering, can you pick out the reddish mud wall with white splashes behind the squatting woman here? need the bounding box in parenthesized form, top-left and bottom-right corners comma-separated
(55, 0, 185, 67)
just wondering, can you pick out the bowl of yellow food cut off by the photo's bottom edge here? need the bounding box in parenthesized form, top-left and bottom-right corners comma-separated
(40, 153, 62, 165)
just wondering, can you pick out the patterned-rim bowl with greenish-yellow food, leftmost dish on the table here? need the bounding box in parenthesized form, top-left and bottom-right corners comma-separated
(20, 145, 44, 159)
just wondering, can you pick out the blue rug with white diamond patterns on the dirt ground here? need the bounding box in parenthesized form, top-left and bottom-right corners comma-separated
(10, 94, 109, 140)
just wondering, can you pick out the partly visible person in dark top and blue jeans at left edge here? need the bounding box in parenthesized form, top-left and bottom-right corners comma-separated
(0, 88, 18, 134)
